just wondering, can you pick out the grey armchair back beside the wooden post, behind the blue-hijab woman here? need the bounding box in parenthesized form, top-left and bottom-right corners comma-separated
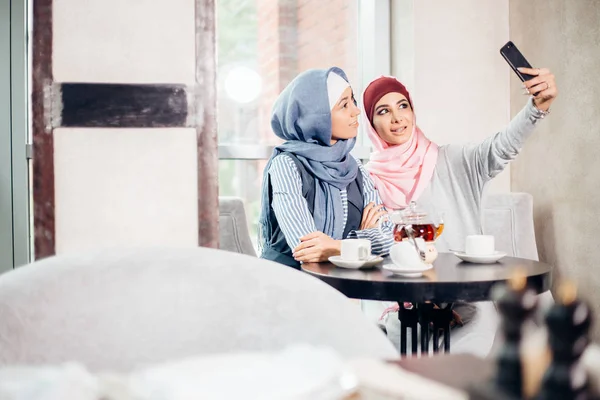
(219, 197, 256, 256)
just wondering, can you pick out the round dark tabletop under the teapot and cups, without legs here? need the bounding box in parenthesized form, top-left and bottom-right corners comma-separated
(302, 253, 552, 302)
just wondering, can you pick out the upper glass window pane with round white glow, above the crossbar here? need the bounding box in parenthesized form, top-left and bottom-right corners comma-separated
(216, 0, 358, 144)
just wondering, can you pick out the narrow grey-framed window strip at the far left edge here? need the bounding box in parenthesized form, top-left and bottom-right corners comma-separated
(0, 0, 30, 273)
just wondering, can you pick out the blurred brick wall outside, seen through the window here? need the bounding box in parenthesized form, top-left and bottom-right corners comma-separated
(257, 0, 357, 143)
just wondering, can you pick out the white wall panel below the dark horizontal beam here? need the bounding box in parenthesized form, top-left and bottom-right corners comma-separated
(54, 128, 198, 254)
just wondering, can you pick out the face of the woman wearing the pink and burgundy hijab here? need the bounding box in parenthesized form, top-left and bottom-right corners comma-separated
(373, 92, 414, 145)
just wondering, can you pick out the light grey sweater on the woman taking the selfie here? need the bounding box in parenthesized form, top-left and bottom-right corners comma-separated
(417, 99, 542, 252)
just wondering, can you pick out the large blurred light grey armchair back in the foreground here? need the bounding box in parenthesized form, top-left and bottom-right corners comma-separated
(0, 248, 397, 371)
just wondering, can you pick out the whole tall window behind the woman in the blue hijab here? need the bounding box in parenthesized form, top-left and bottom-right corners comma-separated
(216, 0, 389, 250)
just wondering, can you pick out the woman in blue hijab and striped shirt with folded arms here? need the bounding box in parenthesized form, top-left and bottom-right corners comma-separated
(259, 67, 393, 268)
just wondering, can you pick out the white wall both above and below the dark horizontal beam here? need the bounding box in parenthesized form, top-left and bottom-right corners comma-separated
(53, 0, 198, 254)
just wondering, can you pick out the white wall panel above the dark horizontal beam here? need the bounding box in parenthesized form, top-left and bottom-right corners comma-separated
(52, 0, 196, 84)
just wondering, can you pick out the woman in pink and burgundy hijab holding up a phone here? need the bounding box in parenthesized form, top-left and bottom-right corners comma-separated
(363, 68, 557, 356)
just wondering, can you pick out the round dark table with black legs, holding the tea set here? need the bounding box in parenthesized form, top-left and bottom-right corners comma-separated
(302, 253, 552, 354)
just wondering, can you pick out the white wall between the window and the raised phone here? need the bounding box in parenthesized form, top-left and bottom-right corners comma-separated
(391, 0, 512, 192)
